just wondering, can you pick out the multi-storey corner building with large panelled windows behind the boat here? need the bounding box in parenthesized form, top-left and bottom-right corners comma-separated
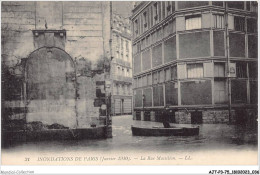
(131, 1, 258, 124)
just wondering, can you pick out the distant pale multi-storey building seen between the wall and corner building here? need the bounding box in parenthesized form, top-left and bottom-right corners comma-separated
(110, 13, 132, 115)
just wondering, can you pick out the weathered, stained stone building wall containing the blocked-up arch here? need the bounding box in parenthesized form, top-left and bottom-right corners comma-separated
(1, 1, 111, 128)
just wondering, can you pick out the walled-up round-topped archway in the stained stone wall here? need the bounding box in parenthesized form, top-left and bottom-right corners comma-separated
(24, 47, 77, 128)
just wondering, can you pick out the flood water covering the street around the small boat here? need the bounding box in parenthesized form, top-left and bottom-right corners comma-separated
(4, 115, 258, 153)
